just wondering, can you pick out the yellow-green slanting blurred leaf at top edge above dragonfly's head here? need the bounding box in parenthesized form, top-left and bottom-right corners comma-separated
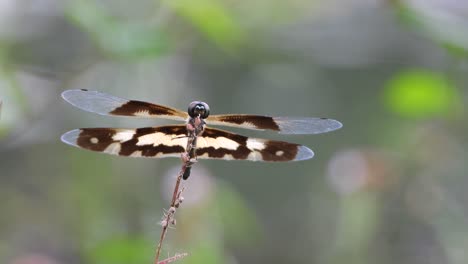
(165, 0, 244, 50)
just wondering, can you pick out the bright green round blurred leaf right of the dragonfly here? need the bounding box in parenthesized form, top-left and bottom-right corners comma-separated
(384, 69, 459, 118)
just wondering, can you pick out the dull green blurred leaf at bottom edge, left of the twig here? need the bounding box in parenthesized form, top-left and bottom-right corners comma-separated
(88, 238, 154, 264)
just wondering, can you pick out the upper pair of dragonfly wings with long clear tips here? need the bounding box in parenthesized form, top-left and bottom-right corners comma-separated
(62, 90, 342, 134)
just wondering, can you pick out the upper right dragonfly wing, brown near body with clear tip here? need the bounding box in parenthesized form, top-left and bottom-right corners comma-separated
(206, 115, 342, 134)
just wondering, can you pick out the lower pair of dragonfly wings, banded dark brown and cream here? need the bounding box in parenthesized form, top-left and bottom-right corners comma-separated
(62, 125, 314, 162)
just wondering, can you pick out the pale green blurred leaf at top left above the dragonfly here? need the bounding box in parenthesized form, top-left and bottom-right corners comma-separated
(67, 0, 169, 59)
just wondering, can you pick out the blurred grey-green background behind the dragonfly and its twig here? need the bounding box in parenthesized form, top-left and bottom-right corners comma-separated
(0, 0, 468, 264)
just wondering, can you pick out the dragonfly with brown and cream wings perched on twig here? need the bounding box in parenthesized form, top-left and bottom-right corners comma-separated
(61, 89, 342, 177)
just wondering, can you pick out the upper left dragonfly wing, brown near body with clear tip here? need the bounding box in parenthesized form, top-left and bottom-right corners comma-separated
(62, 90, 188, 121)
